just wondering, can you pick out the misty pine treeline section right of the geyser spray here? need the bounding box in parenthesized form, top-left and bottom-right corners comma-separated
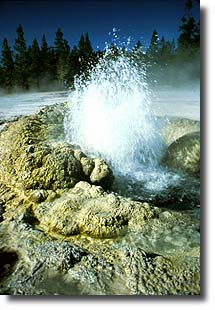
(135, 0, 200, 86)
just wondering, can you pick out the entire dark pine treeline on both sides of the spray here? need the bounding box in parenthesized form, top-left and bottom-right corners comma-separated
(0, 0, 200, 92)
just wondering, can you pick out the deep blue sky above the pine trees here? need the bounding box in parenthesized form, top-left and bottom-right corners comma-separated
(0, 0, 199, 50)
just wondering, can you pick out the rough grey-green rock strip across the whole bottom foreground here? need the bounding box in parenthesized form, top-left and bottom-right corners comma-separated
(0, 207, 200, 296)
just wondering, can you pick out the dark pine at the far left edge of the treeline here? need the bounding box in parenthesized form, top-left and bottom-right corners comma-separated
(1, 38, 14, 92)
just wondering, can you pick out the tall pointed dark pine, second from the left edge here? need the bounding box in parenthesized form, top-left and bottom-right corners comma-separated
(14, 25, 29, 89)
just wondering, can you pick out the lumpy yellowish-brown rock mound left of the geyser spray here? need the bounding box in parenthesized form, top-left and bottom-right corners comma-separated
(0, 118, 84, 190)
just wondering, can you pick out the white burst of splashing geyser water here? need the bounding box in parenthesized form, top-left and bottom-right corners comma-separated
(65, 45, 180, 196)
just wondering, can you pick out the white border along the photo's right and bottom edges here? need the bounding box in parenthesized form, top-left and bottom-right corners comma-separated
(0, 0, 212, 310)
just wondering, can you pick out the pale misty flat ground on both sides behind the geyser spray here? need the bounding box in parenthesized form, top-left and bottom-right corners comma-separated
(0, 86, 200, 124)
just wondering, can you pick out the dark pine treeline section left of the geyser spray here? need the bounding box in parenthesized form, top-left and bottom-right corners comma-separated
(0, 25, 98, 91)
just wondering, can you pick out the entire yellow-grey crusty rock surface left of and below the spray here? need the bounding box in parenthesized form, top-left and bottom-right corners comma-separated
(0, 104, 200, 296)
